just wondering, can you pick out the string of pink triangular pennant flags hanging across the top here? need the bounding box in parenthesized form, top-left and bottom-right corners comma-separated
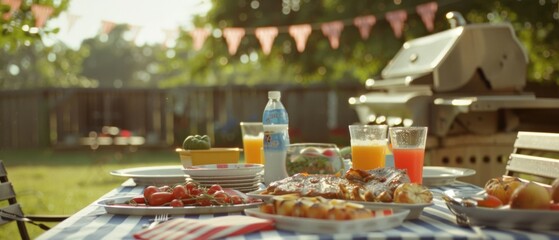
(1, 0, 438, 55)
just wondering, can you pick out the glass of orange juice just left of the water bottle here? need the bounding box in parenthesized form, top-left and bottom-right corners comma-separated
(240, 122, 264, 164)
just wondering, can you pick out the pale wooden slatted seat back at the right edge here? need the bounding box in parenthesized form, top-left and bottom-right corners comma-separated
(506, 131, 559, 184)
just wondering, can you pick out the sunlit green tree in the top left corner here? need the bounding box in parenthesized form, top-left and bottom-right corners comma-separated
(0, 0, 96, 89)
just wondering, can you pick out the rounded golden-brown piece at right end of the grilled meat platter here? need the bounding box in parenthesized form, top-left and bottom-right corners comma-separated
(394, 183, 433, 204)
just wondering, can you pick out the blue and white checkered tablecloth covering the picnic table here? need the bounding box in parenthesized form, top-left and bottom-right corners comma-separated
(38, 181, 559, 240)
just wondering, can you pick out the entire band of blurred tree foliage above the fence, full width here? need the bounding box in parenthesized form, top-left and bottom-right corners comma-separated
(0, 0, 559, 89)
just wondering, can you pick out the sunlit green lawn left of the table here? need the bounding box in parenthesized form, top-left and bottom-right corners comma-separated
(0, 149, 180, 239)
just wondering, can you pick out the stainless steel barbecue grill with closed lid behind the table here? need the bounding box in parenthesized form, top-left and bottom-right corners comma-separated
(349, 13, 559, 185)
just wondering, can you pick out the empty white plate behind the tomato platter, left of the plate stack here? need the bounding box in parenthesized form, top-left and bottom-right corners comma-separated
(110, 165, 187, 186)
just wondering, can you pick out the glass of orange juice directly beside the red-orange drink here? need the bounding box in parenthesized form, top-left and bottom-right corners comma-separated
(349, 125, 388, 170)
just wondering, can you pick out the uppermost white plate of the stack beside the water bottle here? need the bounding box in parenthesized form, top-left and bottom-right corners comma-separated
(183, 164, 264, 178)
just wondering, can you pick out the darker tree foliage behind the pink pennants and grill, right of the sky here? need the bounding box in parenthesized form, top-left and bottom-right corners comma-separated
(158, 0, 559, 87)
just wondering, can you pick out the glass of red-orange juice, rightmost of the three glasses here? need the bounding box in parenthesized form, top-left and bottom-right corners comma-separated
(389, 127, 427, 184)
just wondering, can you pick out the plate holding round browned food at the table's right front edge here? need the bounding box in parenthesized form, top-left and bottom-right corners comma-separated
(447, 204, 559, 231)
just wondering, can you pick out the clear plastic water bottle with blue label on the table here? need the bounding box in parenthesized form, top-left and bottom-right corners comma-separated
(262, 91, 289, 185)
